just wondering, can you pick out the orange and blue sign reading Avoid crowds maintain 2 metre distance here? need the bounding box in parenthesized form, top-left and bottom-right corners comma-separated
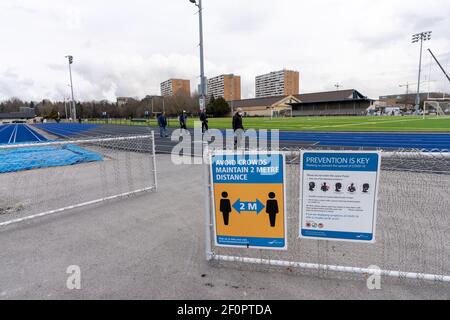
(210, 152, 287, 250)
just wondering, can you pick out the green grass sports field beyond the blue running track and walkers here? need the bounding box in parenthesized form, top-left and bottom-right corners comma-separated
(88, 116, 450, 132)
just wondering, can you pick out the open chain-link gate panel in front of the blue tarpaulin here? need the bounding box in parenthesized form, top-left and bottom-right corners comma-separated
(0, 135, 156, 226)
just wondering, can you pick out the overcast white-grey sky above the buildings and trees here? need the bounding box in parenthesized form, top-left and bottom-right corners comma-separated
(0, 0, 450, 101)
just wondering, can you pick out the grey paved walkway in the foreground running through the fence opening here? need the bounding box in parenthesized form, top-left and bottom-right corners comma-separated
(0, 155, 450, 299)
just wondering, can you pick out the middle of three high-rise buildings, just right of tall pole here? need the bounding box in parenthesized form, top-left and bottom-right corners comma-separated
(208, 74, 241, 101)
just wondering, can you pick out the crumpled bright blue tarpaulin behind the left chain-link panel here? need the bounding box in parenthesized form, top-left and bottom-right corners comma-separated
(0, 144, 103, 173)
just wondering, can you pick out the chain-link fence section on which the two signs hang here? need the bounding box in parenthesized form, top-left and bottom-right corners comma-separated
(211, 148, 450, 286)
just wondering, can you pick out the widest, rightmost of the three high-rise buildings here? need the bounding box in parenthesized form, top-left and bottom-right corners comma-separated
(255, 70, 300, 98)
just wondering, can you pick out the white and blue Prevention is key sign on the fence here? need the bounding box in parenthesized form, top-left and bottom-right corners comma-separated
(300, 151, 381, 243)
